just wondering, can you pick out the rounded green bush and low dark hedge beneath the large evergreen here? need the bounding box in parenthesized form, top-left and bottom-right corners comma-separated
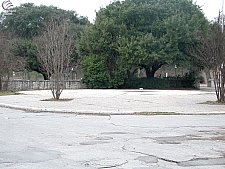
(82, 55, 196, 89)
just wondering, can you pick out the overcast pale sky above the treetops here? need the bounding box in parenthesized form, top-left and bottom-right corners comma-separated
(0, 0, 223, 21)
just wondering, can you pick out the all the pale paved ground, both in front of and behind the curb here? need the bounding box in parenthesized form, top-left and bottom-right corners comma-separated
(0, 88, 225, 169)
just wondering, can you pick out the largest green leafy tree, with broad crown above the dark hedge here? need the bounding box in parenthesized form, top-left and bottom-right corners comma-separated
(79, 0, 208, 86)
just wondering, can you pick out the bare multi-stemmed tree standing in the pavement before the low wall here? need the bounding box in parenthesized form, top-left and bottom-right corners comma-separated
(35, 18, 74, 100)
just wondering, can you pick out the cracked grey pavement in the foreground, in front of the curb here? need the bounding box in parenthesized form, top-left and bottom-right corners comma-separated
(0, 108, 225, 169)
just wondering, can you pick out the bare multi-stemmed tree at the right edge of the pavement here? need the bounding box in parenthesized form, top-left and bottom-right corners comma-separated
(188, 21, 225, 102)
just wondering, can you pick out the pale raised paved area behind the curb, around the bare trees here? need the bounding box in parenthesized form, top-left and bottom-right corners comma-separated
(0, 88, 225, 115)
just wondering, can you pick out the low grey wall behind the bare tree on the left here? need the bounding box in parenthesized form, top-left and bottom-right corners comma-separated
(2, 80, 85, 91)
